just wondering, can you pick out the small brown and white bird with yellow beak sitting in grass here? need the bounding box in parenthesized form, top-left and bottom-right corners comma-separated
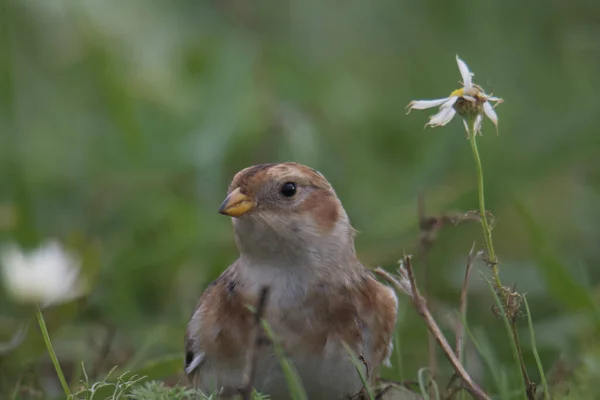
(185, 162, 398, 400)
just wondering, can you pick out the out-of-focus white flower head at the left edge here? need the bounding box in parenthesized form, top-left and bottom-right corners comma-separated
(0, 241, 84, 307)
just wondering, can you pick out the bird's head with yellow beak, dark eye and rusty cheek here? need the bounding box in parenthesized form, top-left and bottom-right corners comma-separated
(219, 163, 355, 265)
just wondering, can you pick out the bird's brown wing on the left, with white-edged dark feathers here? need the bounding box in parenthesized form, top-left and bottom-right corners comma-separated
(185, 263, 253, 379)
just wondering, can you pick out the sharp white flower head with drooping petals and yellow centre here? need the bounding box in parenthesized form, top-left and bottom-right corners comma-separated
(406, 56, 502, 135)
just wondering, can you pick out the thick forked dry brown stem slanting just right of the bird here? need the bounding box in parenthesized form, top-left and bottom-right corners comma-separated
(375, 257, 491, 400)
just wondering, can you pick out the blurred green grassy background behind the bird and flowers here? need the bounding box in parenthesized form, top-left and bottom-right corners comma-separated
(0, 0, 600, 398)
